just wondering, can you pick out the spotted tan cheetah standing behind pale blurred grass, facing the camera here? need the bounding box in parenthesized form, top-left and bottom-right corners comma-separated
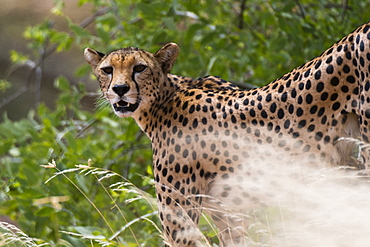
(84, 23, 370, 246)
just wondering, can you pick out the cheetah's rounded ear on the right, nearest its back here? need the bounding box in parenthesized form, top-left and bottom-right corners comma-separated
(154, 43, 180, 74)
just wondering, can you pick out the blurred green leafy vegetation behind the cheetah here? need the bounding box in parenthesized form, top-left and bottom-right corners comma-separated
(0, 0, 370, 246)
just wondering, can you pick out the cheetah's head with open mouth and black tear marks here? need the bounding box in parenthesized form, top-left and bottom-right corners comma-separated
(84, 43, 179, 117)
